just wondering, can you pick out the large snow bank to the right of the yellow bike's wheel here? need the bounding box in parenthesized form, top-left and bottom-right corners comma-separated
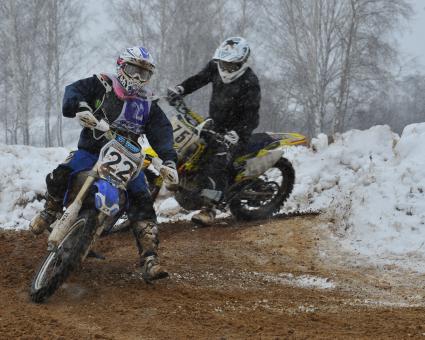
(284, 123, 425, 270)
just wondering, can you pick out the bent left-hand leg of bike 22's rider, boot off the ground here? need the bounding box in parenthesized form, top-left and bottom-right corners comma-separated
(30, 150, 97, 235)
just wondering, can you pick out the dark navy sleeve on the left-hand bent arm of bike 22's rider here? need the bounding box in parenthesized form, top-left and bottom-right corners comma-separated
(62, 76, 105, 118)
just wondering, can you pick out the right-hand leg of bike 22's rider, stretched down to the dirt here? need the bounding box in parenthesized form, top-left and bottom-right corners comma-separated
(127, 173, 168, 282)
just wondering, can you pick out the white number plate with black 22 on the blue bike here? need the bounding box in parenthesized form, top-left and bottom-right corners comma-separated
(99, 146, 138, 184)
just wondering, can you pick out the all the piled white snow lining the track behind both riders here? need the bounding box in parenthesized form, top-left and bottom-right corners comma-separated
(0, 123, 425, 271)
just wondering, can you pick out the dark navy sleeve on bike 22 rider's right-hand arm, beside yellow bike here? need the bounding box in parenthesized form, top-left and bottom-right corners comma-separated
(146, 102, 177, 163)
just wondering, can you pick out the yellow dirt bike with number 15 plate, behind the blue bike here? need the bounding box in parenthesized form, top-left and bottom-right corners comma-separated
(147, 98, 307, 220)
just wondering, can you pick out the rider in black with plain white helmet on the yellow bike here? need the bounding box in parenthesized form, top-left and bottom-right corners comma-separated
(168, 37, 261, 225)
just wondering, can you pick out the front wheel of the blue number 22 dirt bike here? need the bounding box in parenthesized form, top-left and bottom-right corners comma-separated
(30, 210, 97, 303)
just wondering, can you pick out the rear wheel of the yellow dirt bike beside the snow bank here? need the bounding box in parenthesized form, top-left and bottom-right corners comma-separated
(229, 158, 295, 221)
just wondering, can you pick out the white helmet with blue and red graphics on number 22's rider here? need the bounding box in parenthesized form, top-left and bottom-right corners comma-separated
(117, 47, 155, 93)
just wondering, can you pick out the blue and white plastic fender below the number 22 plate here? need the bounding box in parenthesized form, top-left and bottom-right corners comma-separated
(93, 179, 120, 216)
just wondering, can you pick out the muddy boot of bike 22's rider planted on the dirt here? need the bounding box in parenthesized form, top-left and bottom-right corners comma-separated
(131, 221, 168, 283)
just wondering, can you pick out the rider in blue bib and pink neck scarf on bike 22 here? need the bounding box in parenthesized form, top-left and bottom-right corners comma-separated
(30, 47, 178, 281)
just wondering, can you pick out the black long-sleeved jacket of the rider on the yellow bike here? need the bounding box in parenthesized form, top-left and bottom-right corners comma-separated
(180, 60, 261, 143)
